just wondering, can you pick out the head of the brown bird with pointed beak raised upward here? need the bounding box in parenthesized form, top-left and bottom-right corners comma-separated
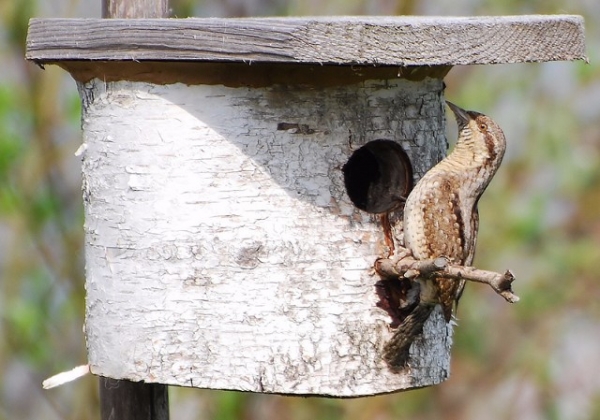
(446, 101, 506, 169)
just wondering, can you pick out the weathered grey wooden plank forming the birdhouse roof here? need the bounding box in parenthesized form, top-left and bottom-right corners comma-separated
(26, 15, 585, 66)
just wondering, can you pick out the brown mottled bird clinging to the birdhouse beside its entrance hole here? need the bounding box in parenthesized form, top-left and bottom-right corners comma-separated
(384, 101, 506, 365)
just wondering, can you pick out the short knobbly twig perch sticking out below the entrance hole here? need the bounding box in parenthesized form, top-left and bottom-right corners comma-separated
(375, 255, 519, 303)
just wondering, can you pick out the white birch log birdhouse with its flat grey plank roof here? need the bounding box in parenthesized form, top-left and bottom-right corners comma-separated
(27, 16, 584, 397)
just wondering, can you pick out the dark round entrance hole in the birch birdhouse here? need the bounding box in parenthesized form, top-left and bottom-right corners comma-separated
(342, 140, 413, 213)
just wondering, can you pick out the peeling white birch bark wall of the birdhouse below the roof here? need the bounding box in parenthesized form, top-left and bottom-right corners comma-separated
(79, 79, 451, 396)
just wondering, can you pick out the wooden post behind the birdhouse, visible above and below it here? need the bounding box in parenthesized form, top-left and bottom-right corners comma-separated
(100, 0, 169, 420)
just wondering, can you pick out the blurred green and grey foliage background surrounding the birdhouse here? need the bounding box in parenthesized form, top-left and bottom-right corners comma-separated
(0, 0, 600, 420)
